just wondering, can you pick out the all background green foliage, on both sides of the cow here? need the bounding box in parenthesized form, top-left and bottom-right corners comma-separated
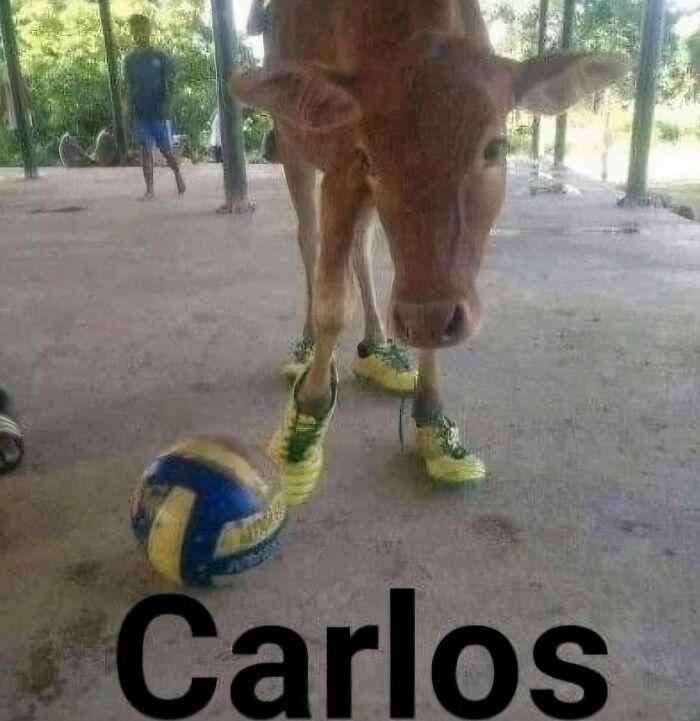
(0, 0, 700, 165)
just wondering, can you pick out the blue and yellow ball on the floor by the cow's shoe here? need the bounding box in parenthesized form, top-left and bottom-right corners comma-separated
(131, 438, 287, 586)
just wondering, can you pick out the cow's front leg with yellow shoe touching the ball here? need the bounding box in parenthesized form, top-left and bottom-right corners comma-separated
(269, 166, 367, 505)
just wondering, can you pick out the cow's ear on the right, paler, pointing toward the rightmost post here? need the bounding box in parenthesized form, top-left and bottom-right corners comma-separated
(514, 53, 629, 115)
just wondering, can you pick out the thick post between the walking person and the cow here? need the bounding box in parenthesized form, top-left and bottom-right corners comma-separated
(211, 0, 253, 213)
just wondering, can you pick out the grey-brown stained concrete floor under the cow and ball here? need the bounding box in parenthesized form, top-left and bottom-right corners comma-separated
(0, 166, 700, 721)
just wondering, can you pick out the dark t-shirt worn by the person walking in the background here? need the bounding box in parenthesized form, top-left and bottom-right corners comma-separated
(124, 48, 171, 120)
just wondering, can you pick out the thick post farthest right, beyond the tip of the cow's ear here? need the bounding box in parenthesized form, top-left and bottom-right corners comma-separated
(625, 0, 666, 203)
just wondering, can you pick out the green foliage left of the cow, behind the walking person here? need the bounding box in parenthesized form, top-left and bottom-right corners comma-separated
(0, 0, 255, 165)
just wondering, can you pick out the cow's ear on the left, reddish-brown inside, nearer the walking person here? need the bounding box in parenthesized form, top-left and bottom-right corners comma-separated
(230, 63, 361, 130)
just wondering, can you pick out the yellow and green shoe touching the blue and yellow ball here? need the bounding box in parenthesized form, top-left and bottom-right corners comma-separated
(268, 366, 338, 506)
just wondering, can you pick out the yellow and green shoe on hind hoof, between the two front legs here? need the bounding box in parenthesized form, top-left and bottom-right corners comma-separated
(353, 340, 418, 395)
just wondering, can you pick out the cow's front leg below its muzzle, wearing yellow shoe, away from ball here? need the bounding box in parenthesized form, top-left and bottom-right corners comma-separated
(413, 351, 486, 483)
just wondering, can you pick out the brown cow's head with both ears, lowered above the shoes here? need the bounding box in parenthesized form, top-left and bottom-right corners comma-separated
(232, 34, 626, 348)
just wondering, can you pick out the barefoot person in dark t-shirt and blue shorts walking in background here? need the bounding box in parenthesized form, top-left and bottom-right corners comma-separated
(124, 15, 185, 200)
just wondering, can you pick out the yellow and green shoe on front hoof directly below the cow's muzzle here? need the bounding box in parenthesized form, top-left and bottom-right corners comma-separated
(414, 415, 486, 483)
